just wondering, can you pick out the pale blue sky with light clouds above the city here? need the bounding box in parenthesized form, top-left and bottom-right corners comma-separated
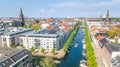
(0, 0, 120, 17)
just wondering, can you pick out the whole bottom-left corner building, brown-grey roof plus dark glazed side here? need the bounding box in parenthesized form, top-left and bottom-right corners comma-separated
(0, 48, 32, 67)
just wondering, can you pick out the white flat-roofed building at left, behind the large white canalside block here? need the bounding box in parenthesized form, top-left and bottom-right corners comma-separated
(1, 27, 33, 47)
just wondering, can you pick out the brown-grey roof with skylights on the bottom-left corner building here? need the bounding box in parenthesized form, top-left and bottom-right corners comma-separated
(0, 48, 31, 67)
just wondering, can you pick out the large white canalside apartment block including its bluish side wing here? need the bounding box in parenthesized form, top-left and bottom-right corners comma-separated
(20, 29, 67, 50)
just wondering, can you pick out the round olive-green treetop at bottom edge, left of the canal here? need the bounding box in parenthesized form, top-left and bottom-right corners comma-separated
(40, 57, 57, 67)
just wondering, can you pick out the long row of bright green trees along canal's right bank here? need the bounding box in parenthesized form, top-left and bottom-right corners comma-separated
(84, 21, 97, 67)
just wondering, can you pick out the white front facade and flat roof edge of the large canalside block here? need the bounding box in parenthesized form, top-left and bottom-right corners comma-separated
(20, 33, 60, 50)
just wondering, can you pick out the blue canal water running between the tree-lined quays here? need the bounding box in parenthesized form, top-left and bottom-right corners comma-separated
(57, 28, 83, 67)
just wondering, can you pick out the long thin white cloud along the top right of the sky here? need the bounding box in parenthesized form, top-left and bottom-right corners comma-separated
(53, 0, 120, 8)
